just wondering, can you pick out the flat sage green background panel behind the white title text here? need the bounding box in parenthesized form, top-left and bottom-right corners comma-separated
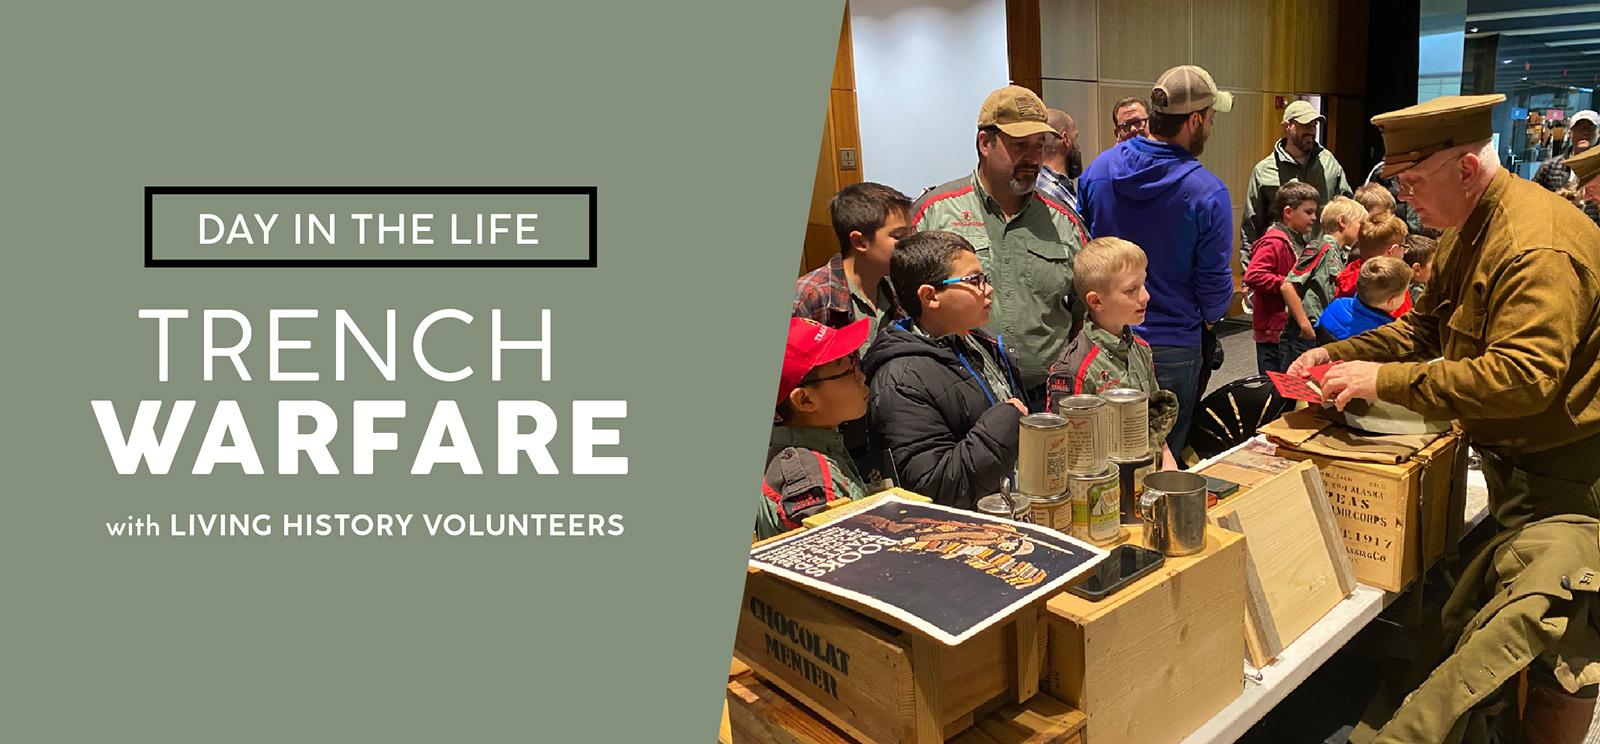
(0, 0, 842, 742)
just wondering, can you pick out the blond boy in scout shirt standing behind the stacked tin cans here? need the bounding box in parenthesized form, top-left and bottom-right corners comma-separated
(1048, 238, 1178, 470)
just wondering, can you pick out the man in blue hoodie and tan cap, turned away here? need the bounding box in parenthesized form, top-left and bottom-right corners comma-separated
(1078, 64, 1234, 458)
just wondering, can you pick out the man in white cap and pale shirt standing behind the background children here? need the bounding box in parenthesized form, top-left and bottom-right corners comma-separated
(1238, 101, 1352, 262)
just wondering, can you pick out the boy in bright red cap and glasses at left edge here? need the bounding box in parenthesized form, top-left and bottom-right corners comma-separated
(755, 318, 872, 539)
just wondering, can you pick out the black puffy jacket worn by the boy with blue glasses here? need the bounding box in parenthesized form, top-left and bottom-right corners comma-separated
(861, 320, 1022, 509)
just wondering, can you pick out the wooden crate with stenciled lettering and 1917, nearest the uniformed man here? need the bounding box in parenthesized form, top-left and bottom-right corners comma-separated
(1278, 434, 1466, 592)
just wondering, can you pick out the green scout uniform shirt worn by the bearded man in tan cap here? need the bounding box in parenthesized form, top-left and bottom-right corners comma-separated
(910, 171, 1090, 390)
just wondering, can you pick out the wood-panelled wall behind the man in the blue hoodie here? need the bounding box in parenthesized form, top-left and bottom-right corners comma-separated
(1006, 0, 1368, 315)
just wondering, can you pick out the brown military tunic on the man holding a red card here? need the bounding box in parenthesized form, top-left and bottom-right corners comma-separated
(1326, 170, 1600, 454)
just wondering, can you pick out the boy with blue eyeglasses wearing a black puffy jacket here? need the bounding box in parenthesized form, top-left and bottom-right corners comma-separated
(862, 230, 1027, 509)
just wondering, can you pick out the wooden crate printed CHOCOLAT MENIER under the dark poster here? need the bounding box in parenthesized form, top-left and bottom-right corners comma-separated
(733, 570, 1045, 744)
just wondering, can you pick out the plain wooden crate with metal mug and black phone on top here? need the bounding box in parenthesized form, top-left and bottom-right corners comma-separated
(1045, 525, 1245, 744)
